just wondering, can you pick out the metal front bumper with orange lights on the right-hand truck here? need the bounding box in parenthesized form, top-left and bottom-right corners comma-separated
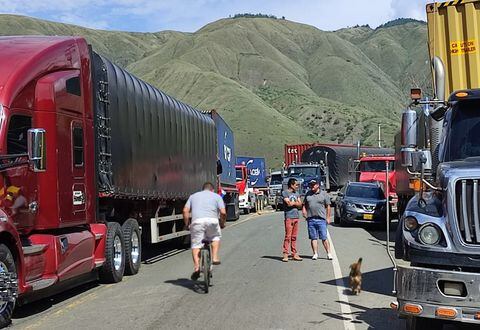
(397, 266, 480, 324)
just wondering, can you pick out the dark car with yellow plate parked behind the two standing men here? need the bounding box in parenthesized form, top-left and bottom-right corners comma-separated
(334, 182, 387, 226)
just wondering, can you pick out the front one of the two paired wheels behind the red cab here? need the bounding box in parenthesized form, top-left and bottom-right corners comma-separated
(99, 222, 125, 283)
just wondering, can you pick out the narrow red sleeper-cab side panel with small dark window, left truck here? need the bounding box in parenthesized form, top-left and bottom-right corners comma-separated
(56, 73, 87, 226)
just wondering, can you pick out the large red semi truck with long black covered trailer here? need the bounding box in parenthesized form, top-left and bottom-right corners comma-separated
(0, 36, 221, 327)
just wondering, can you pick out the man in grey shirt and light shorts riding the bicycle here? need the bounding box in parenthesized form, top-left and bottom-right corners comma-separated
(183, 182, 227, 281)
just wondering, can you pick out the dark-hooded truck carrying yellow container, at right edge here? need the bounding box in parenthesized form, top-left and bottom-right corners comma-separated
(392, 0, 480, 329)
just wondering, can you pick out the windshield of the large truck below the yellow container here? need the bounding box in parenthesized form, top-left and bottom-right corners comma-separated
(444, 101, 480, 162)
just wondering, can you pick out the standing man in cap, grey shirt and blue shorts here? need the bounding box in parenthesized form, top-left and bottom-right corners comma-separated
(302, 180, 332, 260)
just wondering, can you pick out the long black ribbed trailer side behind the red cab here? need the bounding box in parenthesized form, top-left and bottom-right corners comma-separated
(92, 52, 217, 200)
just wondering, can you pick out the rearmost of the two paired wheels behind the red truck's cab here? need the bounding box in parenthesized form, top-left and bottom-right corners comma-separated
(122, 219, 142, 275)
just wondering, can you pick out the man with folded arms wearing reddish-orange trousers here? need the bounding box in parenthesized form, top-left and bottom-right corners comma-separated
(282, 178, 302, 262)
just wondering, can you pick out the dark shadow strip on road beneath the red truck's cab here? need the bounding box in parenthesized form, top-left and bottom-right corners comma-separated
(12, 282, 99, 319)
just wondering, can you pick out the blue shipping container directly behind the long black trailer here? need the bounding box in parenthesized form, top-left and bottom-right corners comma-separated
(207, 110, 236, 187)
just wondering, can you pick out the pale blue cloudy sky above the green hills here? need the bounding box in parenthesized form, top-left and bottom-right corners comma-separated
(0, 0, 432, 32)
